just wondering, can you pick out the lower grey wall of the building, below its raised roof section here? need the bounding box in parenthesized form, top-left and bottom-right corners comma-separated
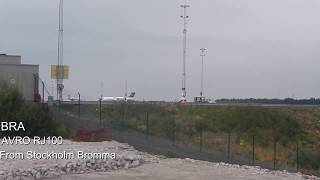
(0, 63, 39, 101)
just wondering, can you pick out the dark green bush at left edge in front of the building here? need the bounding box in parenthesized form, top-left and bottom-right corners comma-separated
(0, 84, 57, 137)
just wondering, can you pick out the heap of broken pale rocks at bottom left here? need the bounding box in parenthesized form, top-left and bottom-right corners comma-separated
(0, 140, 159, 180)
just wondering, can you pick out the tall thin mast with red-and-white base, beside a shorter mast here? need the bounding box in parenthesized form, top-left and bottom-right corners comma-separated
(180, 4, 190, 99)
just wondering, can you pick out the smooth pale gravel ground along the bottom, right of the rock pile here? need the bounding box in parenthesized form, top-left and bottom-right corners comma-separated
(57, 159, 316, 180)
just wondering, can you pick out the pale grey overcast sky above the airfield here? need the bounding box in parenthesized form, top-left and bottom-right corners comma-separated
(0, 0, 320, 100)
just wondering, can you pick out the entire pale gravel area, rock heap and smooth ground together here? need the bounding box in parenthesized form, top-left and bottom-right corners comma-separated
(0, 141, 319, 180)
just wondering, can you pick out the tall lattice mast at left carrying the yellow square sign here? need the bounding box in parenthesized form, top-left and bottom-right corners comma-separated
(57, 0, 64, 102)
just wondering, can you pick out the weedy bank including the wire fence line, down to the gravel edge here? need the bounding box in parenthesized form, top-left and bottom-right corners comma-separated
(55, 103, 320, 175)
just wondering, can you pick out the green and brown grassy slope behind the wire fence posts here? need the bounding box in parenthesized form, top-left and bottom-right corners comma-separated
(62, 103, 320, 171)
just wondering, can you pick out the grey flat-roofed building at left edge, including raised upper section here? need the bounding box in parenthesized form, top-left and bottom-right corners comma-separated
(0, 54, 41, 101)
